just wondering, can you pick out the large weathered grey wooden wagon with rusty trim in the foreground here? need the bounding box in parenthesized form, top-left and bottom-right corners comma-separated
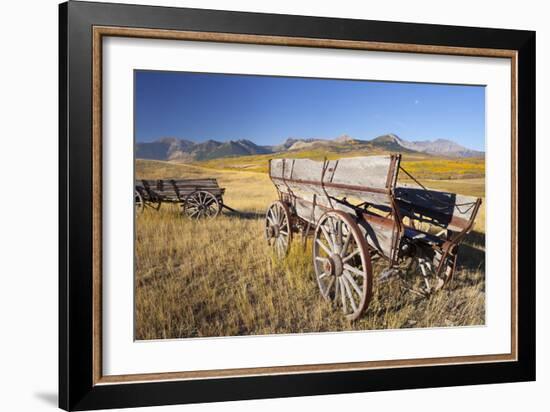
(265, 154, 481, 320)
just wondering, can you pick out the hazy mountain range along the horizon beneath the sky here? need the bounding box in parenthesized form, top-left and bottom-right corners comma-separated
(136, 133, 485, 162)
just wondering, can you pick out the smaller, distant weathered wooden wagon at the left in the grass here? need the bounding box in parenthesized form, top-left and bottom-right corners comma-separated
(134, 178, 233, 219)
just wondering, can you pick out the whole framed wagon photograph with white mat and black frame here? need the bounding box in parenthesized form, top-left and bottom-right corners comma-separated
(59, 1, 535, 410)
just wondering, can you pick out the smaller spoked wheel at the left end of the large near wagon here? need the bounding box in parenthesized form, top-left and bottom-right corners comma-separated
(265, 200, 292, 258)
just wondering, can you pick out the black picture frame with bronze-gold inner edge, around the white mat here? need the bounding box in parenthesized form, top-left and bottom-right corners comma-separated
(59, 1, 535, 410)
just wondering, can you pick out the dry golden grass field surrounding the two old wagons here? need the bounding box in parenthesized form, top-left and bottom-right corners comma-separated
(135, 156, 485, 339)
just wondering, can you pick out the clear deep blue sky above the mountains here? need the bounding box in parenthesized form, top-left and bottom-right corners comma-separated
(135, 71, 485, 150)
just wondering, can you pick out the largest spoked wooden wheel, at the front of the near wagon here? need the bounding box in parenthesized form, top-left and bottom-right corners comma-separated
(313, 210, 372, 320)
